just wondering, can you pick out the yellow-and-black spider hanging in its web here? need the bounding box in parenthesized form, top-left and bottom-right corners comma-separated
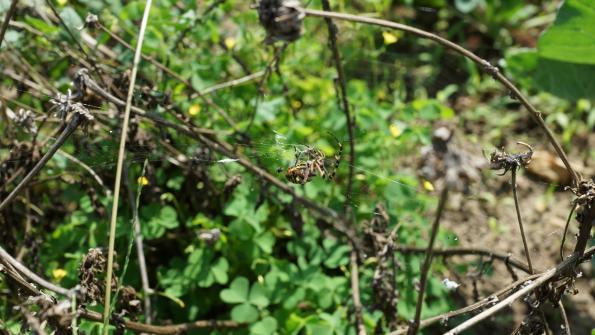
(278, 136, 343, 185)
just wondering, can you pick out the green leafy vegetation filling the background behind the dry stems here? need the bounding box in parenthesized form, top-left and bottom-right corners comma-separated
(0, 0, 595, 335)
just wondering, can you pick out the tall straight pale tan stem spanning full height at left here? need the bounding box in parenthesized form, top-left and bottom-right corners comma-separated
(103, 0, 152, 335)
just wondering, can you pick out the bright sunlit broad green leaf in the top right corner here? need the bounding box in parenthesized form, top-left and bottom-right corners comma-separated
(537, 0, 595, 65)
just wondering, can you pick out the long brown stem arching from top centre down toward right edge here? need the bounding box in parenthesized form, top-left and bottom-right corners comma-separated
(301, 8, 580, 185)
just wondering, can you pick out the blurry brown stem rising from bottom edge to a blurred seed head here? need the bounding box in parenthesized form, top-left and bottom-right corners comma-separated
(407, 185, 448, 335)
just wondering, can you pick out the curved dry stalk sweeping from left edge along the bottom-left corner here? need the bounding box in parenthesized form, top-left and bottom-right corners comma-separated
(0, 247, 246, 334)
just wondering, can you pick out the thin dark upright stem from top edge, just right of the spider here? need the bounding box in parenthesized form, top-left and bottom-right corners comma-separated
(322, 0, 355, 210)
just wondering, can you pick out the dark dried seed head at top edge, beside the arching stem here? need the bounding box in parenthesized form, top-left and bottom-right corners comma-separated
(258, 0, 305, 44)
